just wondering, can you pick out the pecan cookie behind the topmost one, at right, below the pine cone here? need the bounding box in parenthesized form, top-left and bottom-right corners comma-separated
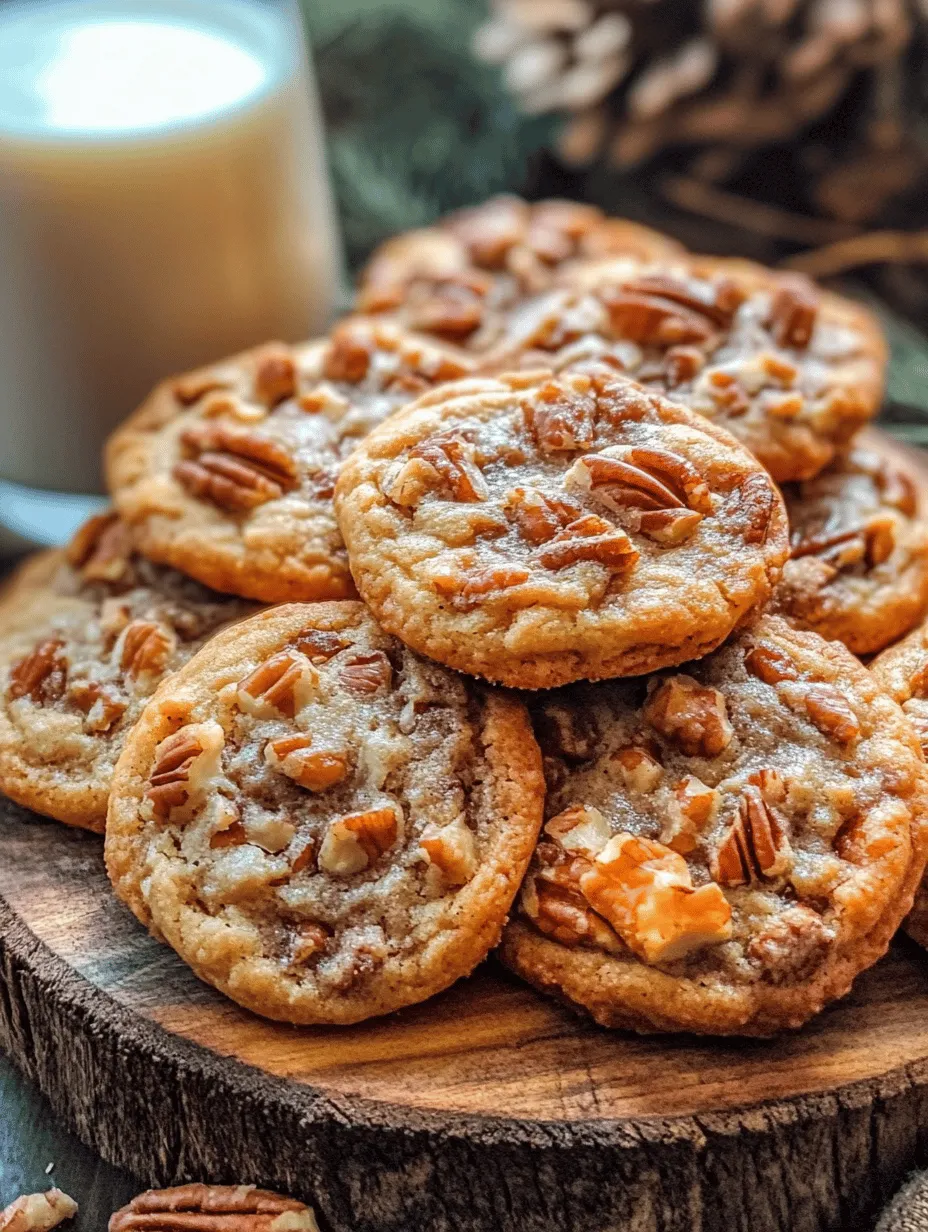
(487, 256, 886, 480)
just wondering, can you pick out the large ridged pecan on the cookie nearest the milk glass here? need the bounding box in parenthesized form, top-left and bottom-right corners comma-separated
(174, 424, 297, 513)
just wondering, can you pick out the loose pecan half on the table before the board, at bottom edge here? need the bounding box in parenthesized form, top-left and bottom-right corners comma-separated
(110, 1185, 319, 1232)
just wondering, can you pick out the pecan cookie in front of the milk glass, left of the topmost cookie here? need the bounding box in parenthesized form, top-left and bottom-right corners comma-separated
(107, 318, 470, 602)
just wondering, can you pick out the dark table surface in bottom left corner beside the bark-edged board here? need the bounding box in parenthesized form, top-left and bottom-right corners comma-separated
(0, 1053, 137, 1232)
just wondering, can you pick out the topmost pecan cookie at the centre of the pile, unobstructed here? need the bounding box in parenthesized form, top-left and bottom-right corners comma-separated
(335, 370, 789, 689)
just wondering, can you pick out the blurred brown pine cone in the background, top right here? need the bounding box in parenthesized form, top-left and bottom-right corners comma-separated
(476, 0, 928, 223)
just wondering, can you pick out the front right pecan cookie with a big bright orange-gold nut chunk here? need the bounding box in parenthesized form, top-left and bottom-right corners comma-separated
(502, 616, 928, 1035)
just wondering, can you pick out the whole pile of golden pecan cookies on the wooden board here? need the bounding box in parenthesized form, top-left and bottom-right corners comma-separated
(0, 198, 928, 1034)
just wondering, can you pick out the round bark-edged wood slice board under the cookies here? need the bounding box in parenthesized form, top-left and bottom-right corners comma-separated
(0, 436, 928, 1232)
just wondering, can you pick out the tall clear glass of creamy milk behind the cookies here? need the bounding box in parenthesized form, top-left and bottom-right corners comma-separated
(0, 0, 340, 541)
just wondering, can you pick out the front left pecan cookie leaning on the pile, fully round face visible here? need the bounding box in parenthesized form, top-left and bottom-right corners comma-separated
(106, 602, 543, 1023)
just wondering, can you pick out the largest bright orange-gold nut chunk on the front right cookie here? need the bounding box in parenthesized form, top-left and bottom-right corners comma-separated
(579, 834, 732, 962)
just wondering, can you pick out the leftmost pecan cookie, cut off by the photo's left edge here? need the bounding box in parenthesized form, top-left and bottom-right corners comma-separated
(0, 514, 255, 830)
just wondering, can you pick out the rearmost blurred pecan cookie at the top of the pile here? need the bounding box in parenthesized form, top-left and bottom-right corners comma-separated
(357, 196, 684, 351)
